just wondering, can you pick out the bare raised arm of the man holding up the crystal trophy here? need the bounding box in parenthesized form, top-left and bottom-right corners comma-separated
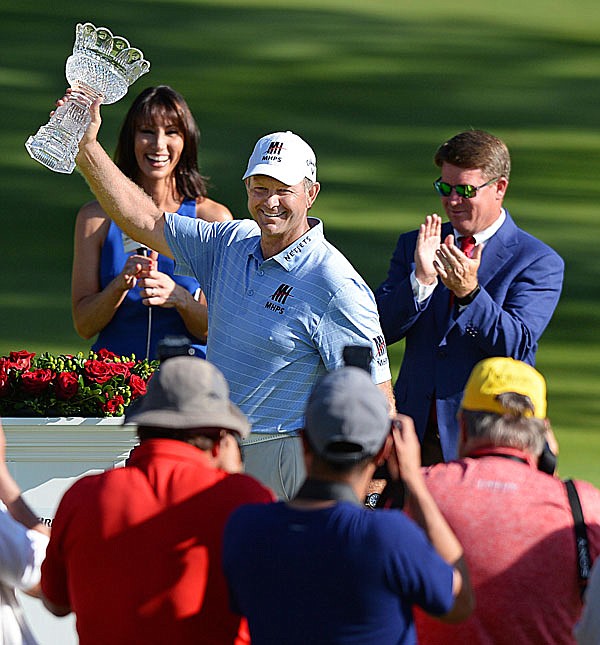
(75, 96, 173, 258)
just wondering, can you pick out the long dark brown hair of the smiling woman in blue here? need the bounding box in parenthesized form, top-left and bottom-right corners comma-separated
(115, 85, 207, 199)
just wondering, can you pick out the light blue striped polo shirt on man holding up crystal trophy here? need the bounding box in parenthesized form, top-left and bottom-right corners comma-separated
(165, 213, 391, 434)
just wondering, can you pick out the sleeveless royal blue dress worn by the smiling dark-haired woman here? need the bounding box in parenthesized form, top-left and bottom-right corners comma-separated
(92, 199, 206, 359)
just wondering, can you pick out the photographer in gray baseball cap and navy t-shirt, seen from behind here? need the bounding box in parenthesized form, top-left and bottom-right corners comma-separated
(223, 367, 473, 645)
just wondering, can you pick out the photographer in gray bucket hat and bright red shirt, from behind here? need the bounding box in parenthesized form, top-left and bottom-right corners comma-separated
(42, 355, 273, 645)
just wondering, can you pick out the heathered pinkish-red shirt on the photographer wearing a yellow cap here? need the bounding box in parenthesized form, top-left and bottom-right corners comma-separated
(415, 448, 600, 645)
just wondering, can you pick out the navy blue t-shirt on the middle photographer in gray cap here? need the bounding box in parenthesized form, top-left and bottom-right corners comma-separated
(223, 502, 454, 645)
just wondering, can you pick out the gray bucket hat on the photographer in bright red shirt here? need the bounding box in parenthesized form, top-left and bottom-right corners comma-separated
(125, 356, 250, 439)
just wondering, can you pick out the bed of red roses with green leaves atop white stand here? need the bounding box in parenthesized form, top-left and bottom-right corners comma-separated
(0, 349, 158, 417)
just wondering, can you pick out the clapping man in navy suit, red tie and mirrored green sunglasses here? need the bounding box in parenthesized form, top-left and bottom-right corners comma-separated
(375, 130, 564, 465)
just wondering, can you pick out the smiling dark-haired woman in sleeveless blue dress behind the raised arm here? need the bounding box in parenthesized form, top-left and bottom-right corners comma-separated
(71, 85, 232, 358)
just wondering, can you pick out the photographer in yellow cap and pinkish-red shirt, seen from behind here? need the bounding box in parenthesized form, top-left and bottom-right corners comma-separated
(416, 357, 600, 645)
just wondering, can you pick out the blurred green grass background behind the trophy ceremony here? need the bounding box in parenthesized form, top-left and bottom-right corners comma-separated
(0, 0, 600, 485)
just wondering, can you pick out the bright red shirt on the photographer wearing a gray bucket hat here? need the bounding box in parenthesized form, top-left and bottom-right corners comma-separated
(42, 439, 273, 645)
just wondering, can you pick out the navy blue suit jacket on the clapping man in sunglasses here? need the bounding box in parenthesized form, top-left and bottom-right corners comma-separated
(375, 212, 564, 461)
